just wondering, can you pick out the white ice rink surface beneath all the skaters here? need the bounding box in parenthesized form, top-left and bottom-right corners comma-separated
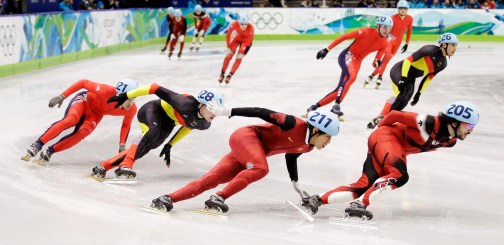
(0, 41, 504, 245)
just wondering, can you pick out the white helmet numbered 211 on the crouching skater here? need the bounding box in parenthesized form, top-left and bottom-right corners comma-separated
(306, 109, 339, 136)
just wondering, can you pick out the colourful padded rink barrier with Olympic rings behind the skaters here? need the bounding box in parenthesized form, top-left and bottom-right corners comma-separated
(0, 8, 504, 77)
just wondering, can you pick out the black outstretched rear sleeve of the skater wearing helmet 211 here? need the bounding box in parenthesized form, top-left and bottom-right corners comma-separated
(231, 107, 296, 130)
